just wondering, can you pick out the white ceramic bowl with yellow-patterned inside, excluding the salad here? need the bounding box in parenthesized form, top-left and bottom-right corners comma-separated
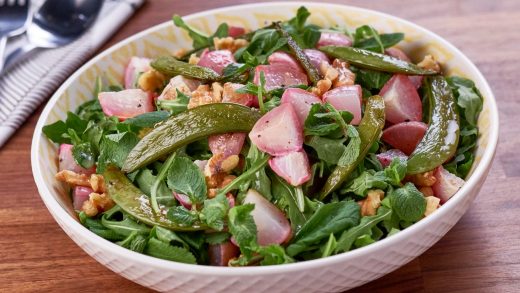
(31, 3, 498, 292)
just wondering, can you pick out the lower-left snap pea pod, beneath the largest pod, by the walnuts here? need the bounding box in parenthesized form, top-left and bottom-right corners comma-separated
(103, 166, 207, 231)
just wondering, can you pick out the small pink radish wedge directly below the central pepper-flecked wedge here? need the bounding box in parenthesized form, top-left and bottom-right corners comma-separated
(269, 150, 311, 186)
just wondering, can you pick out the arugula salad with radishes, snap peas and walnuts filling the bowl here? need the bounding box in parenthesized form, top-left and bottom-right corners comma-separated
(43, 7, 483, 266)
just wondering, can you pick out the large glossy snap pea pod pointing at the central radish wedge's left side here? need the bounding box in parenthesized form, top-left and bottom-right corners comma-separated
(122, 103, 261, 172)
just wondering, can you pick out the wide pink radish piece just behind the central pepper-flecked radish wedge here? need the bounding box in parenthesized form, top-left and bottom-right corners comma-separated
(253, 63, 308, 91)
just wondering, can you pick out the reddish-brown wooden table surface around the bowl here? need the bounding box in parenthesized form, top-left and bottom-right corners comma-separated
(0, 0, 520, 292)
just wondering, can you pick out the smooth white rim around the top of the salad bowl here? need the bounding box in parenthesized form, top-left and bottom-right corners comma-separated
(31, 2, 499, 276)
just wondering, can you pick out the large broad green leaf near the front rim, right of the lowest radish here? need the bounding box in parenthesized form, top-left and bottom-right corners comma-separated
(287, 201, 360, 256)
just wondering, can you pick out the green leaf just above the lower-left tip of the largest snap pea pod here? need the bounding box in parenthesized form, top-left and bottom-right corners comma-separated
(96, 132, 138, 173)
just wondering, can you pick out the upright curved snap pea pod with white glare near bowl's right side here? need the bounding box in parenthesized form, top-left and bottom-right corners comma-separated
(407, 76, 460, 174)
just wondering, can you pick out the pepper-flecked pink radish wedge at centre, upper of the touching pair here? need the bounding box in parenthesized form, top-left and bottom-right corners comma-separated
(249, 103, 303, 156)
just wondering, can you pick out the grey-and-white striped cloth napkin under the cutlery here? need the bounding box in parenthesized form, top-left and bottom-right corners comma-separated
(0, 0, 145, 148)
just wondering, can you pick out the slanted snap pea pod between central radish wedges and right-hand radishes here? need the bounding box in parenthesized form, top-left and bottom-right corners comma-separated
(319, 96, 385, 200)
